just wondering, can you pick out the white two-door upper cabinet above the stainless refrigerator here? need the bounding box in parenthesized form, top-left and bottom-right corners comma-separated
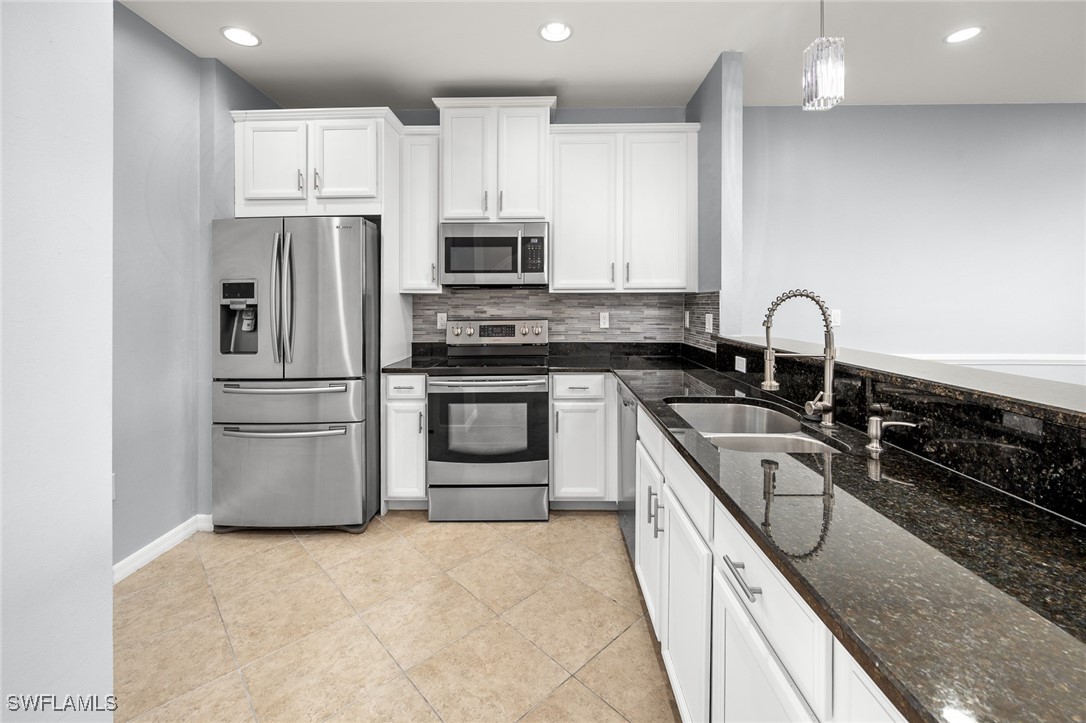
(231, 109, 401, 218)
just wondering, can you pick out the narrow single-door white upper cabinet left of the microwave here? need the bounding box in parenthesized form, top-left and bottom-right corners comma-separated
(400, 127, 441, 293)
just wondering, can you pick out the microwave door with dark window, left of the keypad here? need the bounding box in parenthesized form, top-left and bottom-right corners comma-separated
(438, 224, 525, 287)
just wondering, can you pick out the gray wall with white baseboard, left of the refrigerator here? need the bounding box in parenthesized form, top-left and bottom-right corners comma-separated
(113, 5, 274, 561)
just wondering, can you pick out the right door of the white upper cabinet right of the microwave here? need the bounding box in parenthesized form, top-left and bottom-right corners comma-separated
(622, 134, 689, 290)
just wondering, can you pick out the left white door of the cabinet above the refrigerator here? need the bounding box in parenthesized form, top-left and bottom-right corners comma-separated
(241, 121, 306, 200)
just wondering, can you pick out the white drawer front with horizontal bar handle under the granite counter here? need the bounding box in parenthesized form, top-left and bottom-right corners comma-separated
(712, 501, 833, 720)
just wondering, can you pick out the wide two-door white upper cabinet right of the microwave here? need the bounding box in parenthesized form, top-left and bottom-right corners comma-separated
(551, 124, 698, 292)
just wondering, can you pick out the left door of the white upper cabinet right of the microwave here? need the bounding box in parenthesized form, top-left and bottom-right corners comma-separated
(551, 135, 618, 290)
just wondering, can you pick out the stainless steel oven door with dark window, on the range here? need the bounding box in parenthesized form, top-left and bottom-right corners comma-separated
(427, 377, 551, 486)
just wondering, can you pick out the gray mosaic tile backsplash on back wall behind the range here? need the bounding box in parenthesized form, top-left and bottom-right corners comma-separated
(412, 289, 682, 343)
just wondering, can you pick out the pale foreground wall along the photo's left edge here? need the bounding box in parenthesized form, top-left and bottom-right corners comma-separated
(0, 1, 113, 707)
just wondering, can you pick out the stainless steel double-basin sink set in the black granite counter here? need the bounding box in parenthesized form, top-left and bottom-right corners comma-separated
(665, 397, 838, 455)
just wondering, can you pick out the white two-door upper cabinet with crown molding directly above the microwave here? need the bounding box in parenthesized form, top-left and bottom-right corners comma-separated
(433, 97, 555, 220)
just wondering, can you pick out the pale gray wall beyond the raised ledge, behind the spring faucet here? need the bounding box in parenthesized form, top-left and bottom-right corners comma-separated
(743, 105, 1086, 383)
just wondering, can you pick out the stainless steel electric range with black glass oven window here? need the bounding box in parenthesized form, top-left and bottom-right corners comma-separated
(426, 319, 551, 521)
